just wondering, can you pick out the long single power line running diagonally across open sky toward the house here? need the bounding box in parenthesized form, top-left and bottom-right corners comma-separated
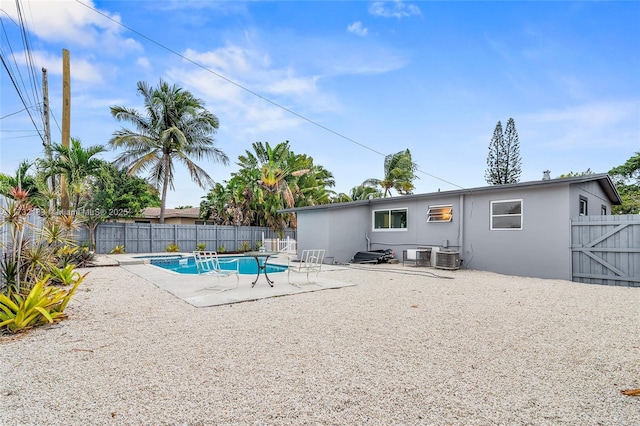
(76, 0, 464, 189)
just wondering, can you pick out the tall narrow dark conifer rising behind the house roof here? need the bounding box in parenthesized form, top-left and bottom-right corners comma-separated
(484, 118, 522, 185)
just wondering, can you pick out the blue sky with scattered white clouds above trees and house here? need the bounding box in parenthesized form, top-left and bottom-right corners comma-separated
(0, 0, 640, 207)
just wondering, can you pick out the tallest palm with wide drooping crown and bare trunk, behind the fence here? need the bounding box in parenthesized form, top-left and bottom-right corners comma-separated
(109, 80, 229, 223)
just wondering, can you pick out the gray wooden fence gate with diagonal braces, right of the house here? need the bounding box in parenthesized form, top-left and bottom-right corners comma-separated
(571, 215, 640, 287)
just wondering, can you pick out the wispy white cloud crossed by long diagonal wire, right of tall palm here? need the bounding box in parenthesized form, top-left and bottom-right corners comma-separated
(168, 45, 336, 138)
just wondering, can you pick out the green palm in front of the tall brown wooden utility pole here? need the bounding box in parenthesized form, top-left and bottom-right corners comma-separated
(42, 138, 105, 217)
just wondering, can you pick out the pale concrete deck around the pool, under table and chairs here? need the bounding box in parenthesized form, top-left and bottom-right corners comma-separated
(94, 253, 355, 308)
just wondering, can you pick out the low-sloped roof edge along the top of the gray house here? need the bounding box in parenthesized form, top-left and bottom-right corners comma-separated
(279, 173, 622, 213)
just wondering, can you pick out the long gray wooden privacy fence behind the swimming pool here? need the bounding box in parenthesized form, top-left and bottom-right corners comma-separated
(77, 222, 296, 253)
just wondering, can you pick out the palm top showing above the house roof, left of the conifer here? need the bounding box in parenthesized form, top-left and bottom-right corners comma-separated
(362, 149, 418, 197)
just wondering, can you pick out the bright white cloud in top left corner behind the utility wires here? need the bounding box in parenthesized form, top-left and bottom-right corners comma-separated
(0, 0, 141, 53)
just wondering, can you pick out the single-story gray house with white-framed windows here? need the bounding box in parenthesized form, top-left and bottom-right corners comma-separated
(284, 174, 621, 280)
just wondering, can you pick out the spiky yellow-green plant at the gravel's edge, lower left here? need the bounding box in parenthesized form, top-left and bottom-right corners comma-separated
(0, 274, 87, 333)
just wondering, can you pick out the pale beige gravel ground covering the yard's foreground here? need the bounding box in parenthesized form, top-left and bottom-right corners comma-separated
(0, 265, 640, 425)
